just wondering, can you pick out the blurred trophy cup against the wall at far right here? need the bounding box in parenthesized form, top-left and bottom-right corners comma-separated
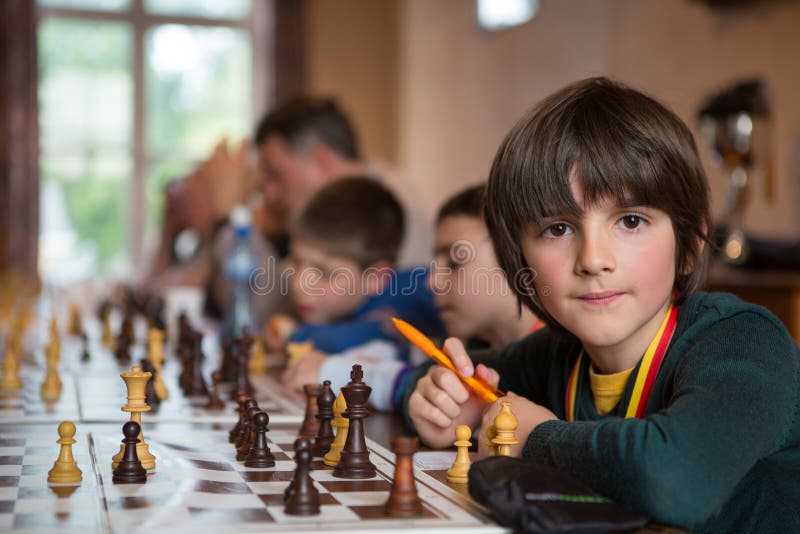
(698, 80, 774, 265)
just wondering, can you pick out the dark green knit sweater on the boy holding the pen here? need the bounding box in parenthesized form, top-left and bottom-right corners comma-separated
(406, 293, 800, 532)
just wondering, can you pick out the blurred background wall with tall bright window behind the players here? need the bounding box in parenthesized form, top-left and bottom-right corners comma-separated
(0, 0, 800, 282)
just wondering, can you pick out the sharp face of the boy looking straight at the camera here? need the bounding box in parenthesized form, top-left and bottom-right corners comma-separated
(521, 180, 676, 368)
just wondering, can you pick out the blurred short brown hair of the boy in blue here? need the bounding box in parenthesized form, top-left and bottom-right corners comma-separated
(290, 176, 405, 268)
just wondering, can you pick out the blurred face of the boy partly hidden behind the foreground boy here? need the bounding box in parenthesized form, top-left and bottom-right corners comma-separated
(427, 215, 517, 339)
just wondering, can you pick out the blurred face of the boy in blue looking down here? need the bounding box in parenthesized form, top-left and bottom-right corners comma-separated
(289, 240, 367, 323)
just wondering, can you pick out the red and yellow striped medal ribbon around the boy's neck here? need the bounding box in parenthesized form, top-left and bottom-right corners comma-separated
(565, 304, 678, 421)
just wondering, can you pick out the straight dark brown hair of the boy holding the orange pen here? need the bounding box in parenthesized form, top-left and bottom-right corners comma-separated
(485, 78, 710, 326)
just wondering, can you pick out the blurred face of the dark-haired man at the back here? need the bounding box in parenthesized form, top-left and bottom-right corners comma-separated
(259, 135, 327, 222)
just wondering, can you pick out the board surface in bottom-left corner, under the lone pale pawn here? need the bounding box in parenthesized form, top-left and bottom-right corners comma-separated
(0, 425, 106, 533)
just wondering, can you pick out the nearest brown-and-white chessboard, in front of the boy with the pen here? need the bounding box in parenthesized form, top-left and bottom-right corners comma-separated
(92, 424, 501, 532)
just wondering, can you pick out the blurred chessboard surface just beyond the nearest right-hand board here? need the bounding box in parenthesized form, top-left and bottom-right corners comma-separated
(77, 372, 303, 425)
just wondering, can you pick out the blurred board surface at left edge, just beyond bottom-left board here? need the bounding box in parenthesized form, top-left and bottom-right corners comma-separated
(0, 367, 80, 423)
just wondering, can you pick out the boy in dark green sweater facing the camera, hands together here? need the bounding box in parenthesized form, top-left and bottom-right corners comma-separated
(406, 78, 800, 532)
